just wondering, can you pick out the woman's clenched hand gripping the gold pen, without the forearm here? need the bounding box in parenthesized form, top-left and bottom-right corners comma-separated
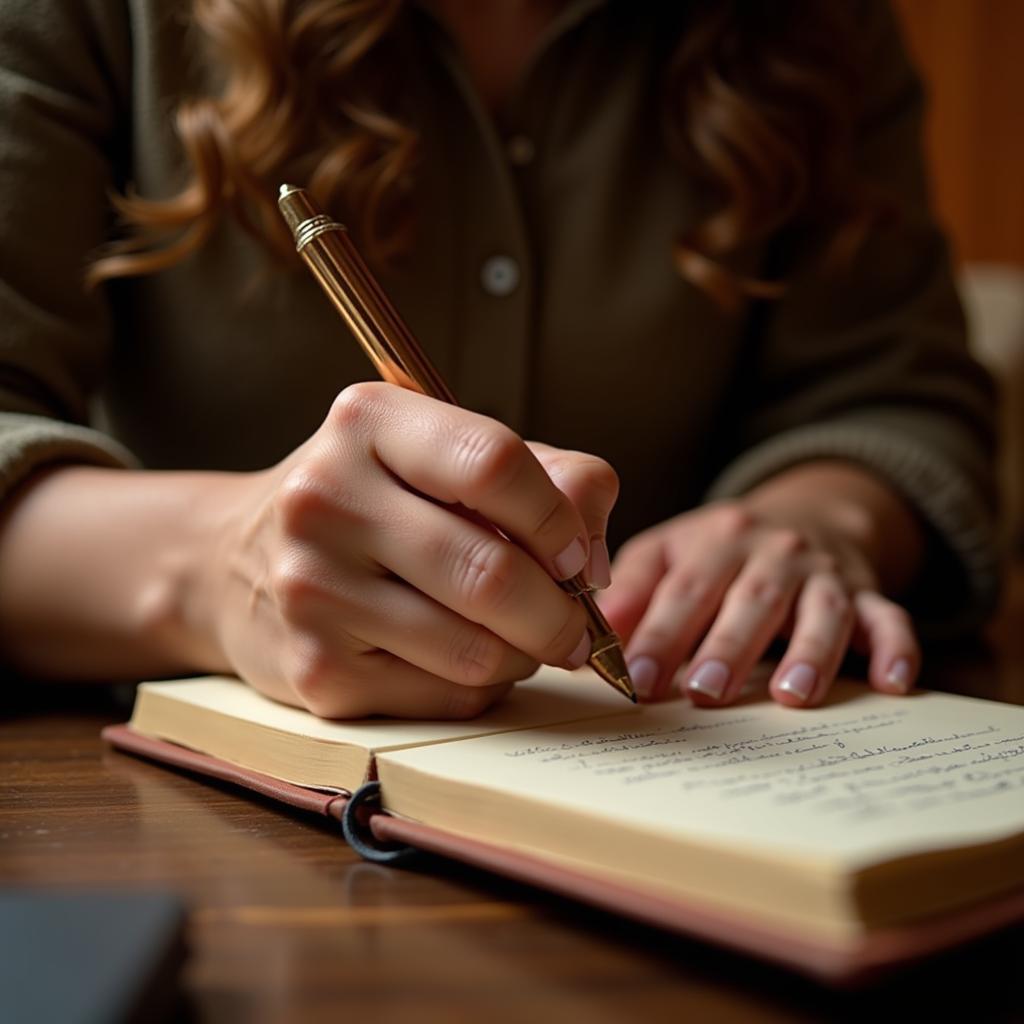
(185, 383, 617, 718)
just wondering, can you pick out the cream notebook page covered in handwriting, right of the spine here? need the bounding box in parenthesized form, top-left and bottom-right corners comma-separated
(381, 683, 1024, 867)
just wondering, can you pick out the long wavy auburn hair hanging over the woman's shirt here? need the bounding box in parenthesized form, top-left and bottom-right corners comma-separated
(89, 0, 879, 307)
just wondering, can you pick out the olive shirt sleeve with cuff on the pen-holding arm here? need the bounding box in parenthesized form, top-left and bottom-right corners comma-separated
(0, 0, 133, 499)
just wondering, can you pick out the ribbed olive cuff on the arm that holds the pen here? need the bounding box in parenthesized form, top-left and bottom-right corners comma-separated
(0, 413, 138, 501)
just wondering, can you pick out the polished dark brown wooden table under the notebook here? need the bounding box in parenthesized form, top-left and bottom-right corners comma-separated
(0, 575, 1024, 1024)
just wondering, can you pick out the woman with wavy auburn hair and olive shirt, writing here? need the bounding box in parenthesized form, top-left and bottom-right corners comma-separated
(0, 0, 995, 716)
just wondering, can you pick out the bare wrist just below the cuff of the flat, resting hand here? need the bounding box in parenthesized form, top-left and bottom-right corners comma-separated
(742, 460, 925, 594)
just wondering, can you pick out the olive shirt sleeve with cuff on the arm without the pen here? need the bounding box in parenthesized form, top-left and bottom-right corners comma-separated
(710, 2, 999, 631)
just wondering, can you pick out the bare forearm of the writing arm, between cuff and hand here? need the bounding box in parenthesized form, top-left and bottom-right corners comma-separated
(0, 466, 239, 679)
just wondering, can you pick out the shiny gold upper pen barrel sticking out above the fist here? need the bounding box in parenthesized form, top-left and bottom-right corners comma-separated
(279, 188, 457, 404)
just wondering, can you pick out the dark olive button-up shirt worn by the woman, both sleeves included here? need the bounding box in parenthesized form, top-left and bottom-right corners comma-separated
(0, 0, 997, 621)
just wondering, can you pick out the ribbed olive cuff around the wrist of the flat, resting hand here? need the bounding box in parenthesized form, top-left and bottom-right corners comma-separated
(708, 423, 1000, 630)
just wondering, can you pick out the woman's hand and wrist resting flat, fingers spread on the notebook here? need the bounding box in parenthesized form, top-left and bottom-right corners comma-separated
(600, 463, 922, 707)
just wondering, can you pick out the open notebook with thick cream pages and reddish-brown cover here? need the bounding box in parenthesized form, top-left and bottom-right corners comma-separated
(106, 670, 1024, 981)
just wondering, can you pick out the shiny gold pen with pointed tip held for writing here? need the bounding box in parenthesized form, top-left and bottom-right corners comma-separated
(278, 185, 637, 703)
